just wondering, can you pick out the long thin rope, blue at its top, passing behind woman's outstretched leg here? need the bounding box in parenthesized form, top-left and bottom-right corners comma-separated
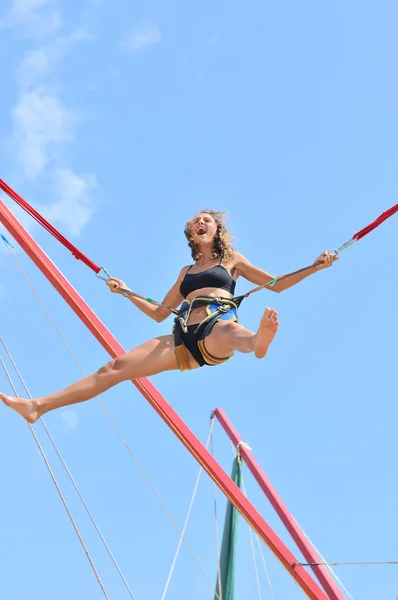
(3, 240, 216, 593)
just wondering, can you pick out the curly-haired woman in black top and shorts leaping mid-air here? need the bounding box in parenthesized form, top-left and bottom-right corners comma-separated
(0, 210, 338, 423)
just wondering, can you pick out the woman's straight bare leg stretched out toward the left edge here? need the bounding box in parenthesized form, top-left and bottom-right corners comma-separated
(0, 335, 194, 423)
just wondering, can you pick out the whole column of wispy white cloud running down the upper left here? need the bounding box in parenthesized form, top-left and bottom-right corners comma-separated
(0, 0, 97, 248)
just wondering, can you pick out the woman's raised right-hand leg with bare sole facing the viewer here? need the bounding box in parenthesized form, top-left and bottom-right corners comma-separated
(205, 308, 279, 358)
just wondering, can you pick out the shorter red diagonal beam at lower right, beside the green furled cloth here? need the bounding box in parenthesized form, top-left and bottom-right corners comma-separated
(213, 408, 344, 600)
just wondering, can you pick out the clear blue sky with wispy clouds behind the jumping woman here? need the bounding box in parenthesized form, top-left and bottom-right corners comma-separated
(0, 0, 398, 600)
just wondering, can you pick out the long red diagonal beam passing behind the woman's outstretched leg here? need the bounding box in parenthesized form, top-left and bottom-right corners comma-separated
(0, 200, 330, 600)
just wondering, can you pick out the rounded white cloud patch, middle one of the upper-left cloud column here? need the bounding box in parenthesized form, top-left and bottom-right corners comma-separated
(12, 89, 76, 179)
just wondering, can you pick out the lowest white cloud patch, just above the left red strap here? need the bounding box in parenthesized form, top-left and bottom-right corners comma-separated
(39, 169, 97, 236)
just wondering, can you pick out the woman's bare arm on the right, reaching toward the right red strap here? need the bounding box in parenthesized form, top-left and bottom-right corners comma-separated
(233, 251, 338, 293)
